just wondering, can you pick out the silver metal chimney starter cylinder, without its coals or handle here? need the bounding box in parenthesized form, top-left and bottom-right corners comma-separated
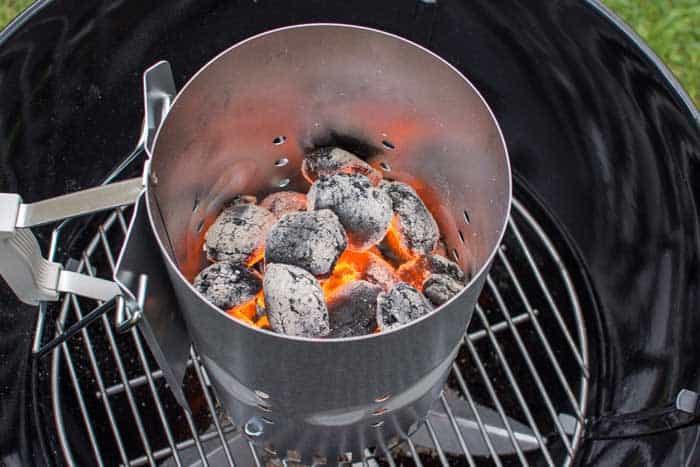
(147, 24, 511, 462)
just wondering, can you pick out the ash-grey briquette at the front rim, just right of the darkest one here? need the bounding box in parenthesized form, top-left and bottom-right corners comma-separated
(377, 282, 432, 331)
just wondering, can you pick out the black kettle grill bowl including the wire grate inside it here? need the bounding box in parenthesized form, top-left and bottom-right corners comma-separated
(0, 0, 700, 467)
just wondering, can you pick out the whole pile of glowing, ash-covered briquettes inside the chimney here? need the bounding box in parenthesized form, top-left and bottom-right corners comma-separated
(194, 147, 466, 338)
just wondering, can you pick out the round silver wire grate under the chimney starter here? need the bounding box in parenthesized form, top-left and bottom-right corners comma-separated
(37, 159, 588, 466)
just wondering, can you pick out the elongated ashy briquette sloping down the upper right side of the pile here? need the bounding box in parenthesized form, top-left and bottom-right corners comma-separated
(380, 181, 440, 256)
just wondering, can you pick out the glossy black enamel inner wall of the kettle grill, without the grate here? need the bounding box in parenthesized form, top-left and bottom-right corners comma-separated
(0, 0, 700, 466)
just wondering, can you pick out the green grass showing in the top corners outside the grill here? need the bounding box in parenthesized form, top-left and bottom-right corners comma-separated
(0, 0, 700, 105)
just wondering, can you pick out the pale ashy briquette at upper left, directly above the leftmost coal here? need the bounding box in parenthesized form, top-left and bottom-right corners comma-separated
(204, 204, 277, 263)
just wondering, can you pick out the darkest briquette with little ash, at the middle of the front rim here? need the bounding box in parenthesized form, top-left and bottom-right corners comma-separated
(328, 281, 382, 337)
